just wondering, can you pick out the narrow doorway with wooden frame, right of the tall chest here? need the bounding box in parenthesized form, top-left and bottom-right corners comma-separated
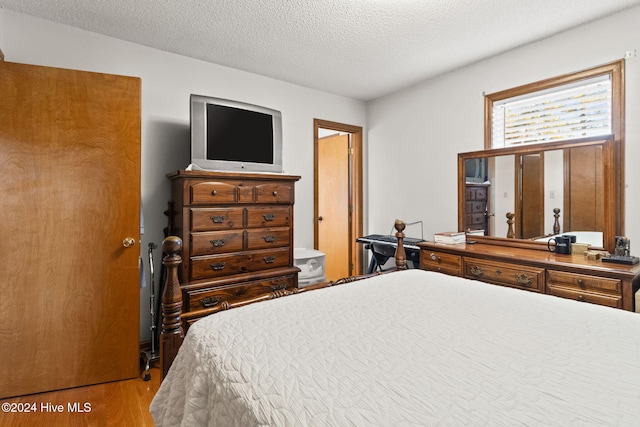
(313, 119, 363, 280)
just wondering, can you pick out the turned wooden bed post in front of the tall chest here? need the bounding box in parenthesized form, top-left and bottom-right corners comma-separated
(160, 236, 184, 378)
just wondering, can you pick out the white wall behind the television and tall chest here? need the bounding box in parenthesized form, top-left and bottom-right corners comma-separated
(0, 8, 365, 340)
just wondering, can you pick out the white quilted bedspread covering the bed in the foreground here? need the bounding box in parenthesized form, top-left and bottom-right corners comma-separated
(151, 270, 640, 427)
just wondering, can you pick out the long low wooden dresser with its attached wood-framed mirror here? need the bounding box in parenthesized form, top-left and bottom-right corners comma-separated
(419, 137, 640, 311)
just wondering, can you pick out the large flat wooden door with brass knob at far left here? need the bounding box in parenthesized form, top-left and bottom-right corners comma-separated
(0, 62, 140, 403)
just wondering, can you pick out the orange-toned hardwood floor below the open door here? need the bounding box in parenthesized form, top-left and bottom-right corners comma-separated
(0, 367, 160, 427)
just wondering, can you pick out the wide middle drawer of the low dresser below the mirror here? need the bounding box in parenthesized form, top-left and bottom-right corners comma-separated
(464, 258, 545, 292)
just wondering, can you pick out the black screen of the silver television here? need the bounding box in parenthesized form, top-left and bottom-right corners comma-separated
(206, 104, 273, 164)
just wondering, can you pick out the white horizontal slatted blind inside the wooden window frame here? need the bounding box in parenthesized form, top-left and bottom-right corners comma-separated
(491, 74, 612, 148)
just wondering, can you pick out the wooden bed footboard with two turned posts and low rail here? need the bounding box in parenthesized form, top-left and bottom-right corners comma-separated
(160, 220, 407, 378)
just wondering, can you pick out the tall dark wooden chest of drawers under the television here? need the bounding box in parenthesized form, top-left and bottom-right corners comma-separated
(167, 171, 300, 322)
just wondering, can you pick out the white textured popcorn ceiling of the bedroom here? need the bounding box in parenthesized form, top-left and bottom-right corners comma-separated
(0, 0, 640, 100)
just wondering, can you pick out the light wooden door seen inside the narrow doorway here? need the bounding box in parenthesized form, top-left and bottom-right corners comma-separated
(317, 134, 352, 280)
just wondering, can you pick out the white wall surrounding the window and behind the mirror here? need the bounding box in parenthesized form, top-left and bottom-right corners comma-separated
(366, 7, 640, 247)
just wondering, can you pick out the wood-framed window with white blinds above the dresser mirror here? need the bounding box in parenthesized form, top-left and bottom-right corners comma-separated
(485, 61, 624, 148)
